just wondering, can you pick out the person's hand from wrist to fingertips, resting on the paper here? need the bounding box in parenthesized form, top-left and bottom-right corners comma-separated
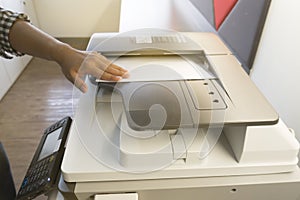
(58, 46, 127, 92)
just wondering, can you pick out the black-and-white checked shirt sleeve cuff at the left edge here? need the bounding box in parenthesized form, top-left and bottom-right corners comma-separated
(0, 7, 30, 58)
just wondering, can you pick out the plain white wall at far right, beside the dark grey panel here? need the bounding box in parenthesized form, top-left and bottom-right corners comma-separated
(251, 0, 300, 140)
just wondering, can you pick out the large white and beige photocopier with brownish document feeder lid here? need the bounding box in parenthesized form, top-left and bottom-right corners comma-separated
(49, 29, 300, 200)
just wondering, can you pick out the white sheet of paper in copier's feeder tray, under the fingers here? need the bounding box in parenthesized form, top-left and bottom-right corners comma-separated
(97, 55, 216, 82)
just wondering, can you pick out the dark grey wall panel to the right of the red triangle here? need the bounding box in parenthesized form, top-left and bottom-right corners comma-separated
(218, 0, 271, 72)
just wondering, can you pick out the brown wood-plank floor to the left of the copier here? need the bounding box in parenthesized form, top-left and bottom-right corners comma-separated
(0, 38, 88, 198)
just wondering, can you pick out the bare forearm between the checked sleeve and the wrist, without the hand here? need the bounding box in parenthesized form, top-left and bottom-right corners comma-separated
(9, 20, 71, 62)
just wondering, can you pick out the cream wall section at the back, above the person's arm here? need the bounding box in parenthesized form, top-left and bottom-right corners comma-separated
(33, 0, 121, 37)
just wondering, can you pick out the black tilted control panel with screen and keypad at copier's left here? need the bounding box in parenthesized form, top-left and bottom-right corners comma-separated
(17, 117, 72, 200)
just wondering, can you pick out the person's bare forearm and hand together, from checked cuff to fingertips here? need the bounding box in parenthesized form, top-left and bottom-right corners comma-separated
(9, 20, 127, 92)
